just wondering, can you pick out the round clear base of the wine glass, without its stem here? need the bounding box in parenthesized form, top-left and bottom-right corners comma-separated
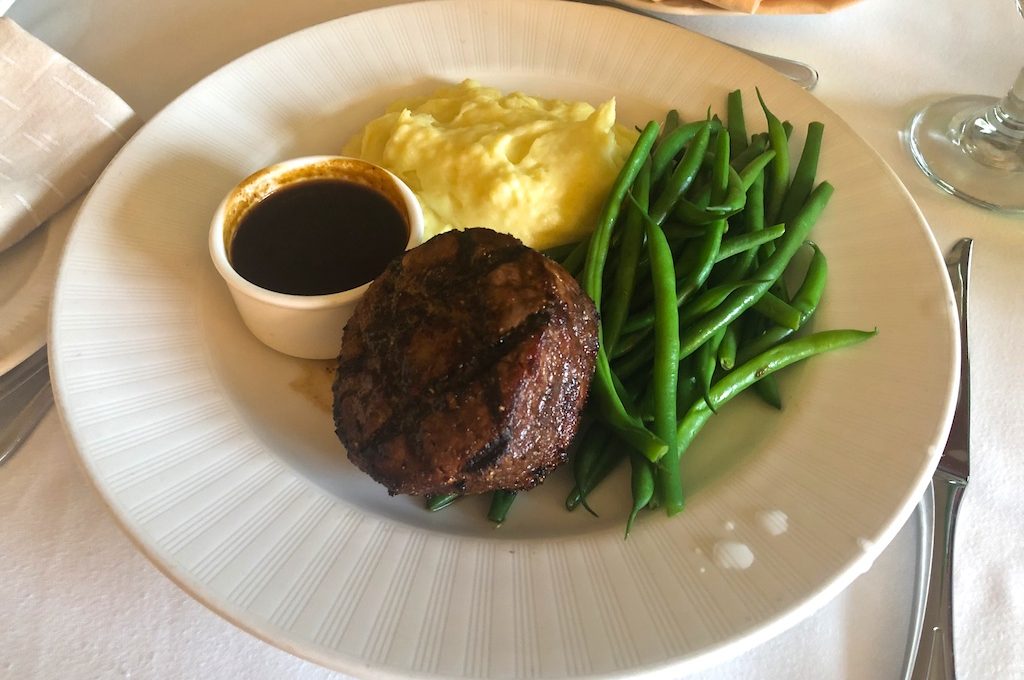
(907, 96, 1024, 214)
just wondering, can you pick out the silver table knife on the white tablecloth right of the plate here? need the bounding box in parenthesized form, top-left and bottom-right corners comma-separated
(907, 239, 974, 680)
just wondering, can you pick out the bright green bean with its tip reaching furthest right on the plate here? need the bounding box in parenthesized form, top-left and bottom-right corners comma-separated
(676, 330, 878, 450)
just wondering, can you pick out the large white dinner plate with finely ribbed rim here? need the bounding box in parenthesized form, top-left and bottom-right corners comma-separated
(51, 0, 958, 678)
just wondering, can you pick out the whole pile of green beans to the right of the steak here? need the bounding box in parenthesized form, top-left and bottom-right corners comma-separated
(427, 90, 877, 536)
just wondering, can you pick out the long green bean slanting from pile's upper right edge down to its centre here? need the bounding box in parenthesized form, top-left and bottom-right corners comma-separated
(679, 182, 834, 357)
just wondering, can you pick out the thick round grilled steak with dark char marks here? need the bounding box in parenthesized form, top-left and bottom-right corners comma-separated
(334, 228, 597, 496)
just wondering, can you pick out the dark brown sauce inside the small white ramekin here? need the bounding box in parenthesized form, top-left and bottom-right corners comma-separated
(229, 179, 409, 295)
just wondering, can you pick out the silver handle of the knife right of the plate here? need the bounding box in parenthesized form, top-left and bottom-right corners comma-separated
(910, 472, 967, 680)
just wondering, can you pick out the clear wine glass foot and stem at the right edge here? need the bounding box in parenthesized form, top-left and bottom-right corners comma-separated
(907, 0, 1024, 214)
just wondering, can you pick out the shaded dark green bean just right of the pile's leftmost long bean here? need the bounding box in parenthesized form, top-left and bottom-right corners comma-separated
(602, 161, 650, 353)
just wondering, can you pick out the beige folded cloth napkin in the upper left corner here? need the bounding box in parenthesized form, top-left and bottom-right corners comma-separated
(0, 16, 140, 252)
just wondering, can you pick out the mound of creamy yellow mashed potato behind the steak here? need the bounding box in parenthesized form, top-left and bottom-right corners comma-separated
(344, 80, 637, 249)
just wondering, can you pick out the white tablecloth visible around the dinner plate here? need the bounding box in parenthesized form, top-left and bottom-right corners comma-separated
(0, 0, 1024, 680)
